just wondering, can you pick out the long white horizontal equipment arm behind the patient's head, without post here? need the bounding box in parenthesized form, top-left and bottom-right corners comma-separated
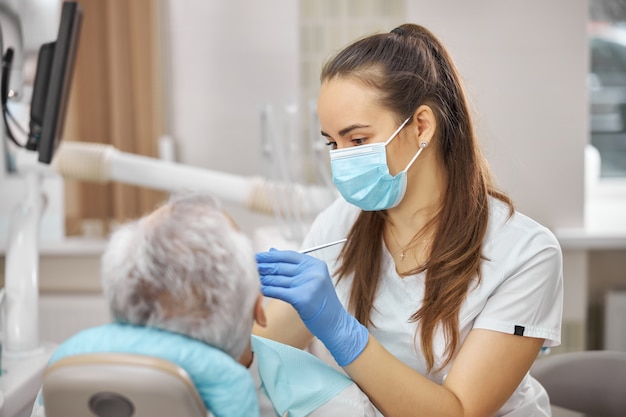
(52, 141, 336, 215)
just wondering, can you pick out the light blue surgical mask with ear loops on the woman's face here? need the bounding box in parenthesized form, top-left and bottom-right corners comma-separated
(330, 118, 427, 211)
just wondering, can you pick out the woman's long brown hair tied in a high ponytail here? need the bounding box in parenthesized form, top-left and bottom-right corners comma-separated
(321, 24, 513, 371)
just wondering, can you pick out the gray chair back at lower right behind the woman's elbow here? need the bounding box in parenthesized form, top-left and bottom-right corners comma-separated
(530, 350, 626, 417)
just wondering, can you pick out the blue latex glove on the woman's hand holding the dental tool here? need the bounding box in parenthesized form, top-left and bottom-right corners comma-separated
(256, 250, 369, 366)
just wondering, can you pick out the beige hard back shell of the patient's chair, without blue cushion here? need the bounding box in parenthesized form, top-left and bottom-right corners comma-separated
(42, 353, 208, 417)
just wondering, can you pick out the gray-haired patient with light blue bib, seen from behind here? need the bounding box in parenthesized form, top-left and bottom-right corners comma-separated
(33, 194, 375, 417)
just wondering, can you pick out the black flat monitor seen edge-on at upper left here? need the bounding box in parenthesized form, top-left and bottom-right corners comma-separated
(27, 1, 82, 164)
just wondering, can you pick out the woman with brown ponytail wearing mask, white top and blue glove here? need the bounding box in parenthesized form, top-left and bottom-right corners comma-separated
(255, 24, 563, 417)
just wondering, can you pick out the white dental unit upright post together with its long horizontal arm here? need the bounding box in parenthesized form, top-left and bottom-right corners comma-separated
(5, 141, 336, 352)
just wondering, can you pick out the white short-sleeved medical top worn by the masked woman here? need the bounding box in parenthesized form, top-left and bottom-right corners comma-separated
(303, 198, 563, 417)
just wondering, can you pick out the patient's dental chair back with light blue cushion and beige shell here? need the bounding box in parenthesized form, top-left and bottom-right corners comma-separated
(34, 323, 259, 417)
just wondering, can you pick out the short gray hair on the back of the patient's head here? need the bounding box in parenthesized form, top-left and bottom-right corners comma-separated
(102, 195, 260, 359)
